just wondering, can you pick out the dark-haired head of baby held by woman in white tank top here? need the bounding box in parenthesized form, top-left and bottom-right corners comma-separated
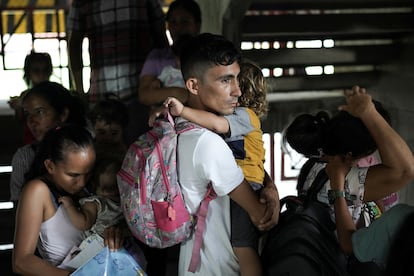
(92, 152, 123, 198)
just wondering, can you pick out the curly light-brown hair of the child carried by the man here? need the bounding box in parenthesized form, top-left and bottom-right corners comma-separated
(238, 60, 267, 117)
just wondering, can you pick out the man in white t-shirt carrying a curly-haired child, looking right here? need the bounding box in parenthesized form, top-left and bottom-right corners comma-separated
(170, 34, 279, 275)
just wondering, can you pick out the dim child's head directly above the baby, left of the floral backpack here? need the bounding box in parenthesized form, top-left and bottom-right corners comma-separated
(90, 99, 129, 147)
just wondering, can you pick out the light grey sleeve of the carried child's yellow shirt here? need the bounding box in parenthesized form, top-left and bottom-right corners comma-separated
(224, 107, 254, 140)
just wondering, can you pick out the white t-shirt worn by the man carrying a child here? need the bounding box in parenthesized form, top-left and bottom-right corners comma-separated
(177, 122, 244, 276)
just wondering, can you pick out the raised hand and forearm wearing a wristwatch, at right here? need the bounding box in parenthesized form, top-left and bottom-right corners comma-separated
(326, 155, 356, 254)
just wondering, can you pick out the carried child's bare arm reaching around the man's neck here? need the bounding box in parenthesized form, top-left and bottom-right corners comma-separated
(164, 97, 230, 134)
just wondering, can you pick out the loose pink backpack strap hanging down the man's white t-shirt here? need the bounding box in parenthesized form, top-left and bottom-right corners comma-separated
(188, 183, 217, 273)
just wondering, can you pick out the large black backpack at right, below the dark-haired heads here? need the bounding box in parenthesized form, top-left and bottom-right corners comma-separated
(261, 159, 347, 276)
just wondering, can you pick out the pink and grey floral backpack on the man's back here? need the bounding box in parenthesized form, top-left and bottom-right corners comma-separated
(117, 112, 215, 272)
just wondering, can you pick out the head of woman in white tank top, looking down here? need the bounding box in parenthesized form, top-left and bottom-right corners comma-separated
(29, 125, 95, 195)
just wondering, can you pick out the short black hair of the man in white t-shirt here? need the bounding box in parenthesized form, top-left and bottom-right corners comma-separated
(180, 33, 241, 80)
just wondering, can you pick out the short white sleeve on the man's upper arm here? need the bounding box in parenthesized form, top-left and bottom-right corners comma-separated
(195, 132, 244, 196)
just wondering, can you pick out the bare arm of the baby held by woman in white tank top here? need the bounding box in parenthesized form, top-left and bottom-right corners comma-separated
(58, 196, 98, 231)
